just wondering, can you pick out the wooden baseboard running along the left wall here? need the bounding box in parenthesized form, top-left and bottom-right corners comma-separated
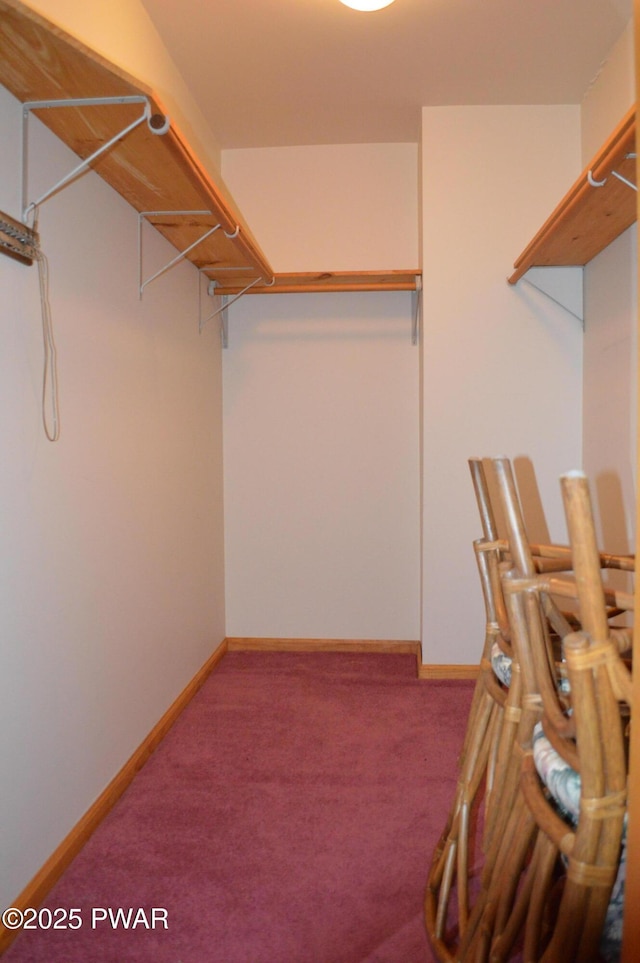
(0, 640, 227, 955)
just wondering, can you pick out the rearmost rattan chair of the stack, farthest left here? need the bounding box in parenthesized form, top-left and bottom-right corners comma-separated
(425, 458, 570, 963)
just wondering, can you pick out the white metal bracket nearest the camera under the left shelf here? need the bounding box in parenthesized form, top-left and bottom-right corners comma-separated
(22, 95, 170, 224)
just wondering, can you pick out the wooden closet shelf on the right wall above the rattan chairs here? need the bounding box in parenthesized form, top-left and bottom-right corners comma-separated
(508, 107, 636, 284)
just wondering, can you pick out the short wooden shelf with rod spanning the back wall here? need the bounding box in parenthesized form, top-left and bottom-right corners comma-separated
(205, 270, 421, 295)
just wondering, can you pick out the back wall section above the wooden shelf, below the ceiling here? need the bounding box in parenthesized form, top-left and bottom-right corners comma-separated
(222, 144, 419, 271)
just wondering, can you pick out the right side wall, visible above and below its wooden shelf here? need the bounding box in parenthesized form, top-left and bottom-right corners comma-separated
(581, 22, 638, 564)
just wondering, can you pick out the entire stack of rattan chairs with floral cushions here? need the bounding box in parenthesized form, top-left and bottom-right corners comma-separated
(425, 459, 633, 963)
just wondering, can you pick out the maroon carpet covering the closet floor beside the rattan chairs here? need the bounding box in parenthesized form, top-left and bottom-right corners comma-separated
(4, 652, 473, 963)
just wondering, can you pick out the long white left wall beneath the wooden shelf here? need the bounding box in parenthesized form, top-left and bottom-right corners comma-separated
(0, 84, 225, 905)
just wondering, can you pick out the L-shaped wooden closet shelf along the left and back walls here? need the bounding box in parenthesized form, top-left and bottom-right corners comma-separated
(0, 0, 418, 294)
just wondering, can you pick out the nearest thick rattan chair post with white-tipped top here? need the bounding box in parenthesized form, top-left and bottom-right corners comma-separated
(549, 472, 632, 959)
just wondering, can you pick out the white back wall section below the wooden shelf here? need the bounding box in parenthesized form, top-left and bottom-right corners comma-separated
(224, 293, 420, 639)
